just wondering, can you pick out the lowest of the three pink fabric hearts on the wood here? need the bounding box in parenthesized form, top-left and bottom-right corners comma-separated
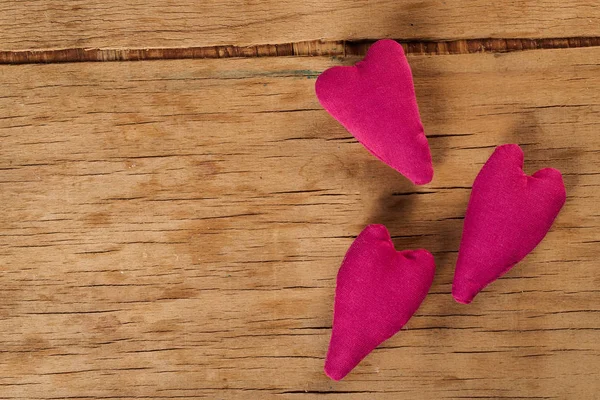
(325, 225, 435, 380)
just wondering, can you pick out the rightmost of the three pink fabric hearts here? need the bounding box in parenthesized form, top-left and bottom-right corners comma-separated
(452, 144, 566, 304)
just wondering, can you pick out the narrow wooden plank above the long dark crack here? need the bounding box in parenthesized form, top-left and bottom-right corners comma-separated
(0, 0, 600, 50)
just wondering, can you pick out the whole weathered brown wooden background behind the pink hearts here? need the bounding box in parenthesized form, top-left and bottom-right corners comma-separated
(0, 0, 600, 400)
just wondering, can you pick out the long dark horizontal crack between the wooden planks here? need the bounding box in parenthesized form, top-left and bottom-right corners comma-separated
(0, 37, 600, 64)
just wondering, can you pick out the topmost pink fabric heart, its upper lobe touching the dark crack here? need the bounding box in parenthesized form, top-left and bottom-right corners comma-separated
(315, 40, 433, 185)
